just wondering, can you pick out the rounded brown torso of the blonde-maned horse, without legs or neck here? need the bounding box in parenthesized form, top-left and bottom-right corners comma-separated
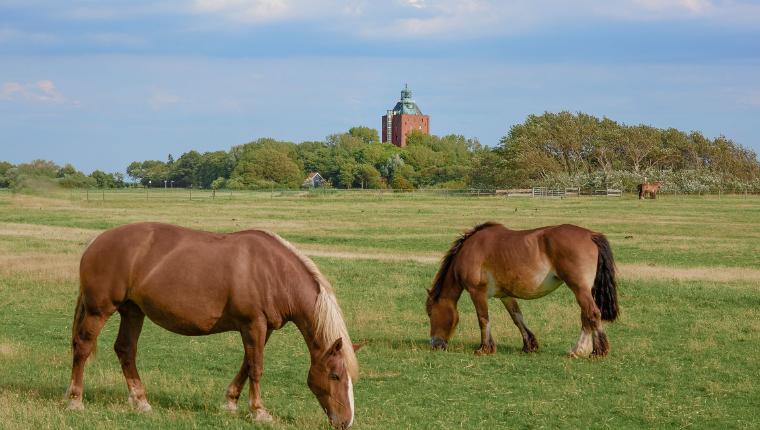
(80, 223, 303, 335)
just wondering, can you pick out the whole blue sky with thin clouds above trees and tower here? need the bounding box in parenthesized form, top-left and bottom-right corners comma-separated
(0, 0, 760, 172)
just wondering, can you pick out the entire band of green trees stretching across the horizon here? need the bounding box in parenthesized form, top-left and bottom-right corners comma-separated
(0, 112, 760, 192)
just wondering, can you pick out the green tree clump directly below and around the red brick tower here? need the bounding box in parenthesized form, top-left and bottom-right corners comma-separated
(127, 127, 481, 189)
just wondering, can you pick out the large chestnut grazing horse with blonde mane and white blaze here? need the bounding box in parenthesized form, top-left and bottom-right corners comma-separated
(66, 223, 358, 428)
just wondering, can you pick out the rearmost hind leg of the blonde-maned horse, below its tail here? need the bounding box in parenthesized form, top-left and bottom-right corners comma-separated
(66, 297, 113, 410)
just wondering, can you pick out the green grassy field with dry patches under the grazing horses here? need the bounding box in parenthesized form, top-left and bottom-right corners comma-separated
(0, 193, 760, 429)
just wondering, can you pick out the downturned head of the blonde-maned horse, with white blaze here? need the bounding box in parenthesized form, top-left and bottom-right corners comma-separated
(308, 338, 358, 429)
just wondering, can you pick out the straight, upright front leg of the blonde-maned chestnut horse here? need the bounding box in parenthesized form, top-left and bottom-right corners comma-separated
(240, 322, 272, 422)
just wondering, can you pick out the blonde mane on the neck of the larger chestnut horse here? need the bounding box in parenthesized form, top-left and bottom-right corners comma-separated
(261, 230, 359, 381)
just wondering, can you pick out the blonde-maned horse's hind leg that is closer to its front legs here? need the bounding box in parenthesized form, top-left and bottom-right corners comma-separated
(113, 302, 152, 412)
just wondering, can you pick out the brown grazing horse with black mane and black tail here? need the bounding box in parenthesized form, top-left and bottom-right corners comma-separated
(427, 222, 618, 357)
